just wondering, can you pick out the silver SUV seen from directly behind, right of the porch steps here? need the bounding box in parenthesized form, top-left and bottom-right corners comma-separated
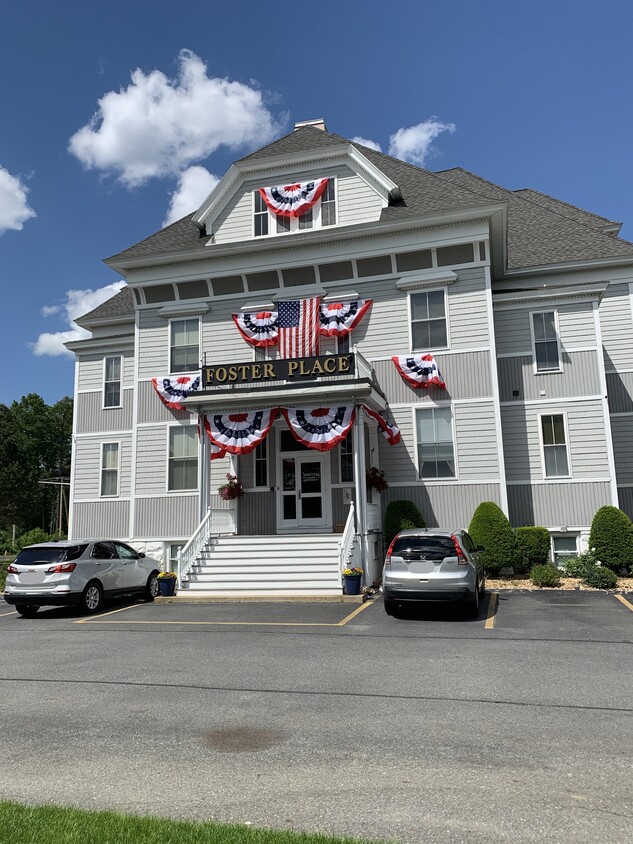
(382, 529, 486, 617)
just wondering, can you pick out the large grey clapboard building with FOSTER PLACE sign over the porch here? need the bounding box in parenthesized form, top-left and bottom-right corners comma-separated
(68, 121, 633, 594)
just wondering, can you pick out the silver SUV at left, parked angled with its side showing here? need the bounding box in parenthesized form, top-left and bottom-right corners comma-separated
(4, 539, 160, 616)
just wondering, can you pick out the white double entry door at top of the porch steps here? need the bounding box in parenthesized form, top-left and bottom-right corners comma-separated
(277, 450, 332, 530)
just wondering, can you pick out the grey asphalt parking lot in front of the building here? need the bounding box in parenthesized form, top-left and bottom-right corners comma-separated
(0, 591, 633, 844)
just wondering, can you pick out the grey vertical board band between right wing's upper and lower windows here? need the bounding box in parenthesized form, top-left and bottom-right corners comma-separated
(497, 352, 600, 401)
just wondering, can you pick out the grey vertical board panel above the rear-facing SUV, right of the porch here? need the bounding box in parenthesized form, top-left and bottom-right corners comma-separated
(382, 484, 500, 530)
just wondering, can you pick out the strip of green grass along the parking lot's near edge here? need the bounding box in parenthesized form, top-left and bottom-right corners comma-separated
(0, 801, 378, 844)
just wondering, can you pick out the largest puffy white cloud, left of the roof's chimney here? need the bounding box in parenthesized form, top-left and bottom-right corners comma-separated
(69, 50, 276, 187)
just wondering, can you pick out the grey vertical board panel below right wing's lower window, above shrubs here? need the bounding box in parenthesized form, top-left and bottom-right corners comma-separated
(508, 483, 611, 528)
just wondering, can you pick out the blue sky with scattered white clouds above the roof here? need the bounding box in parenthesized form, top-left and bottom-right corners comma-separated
(0, 0, 633, 403)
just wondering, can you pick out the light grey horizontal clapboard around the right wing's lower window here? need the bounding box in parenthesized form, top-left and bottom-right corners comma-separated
(501, 401, 609, 486)
